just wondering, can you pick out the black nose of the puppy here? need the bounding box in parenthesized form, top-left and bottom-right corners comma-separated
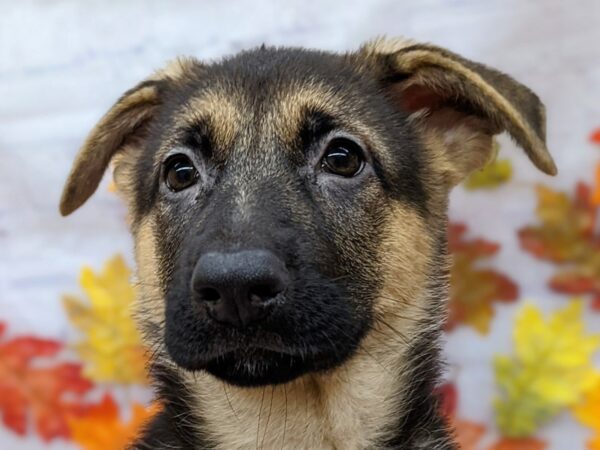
(192, 250, 289, 327)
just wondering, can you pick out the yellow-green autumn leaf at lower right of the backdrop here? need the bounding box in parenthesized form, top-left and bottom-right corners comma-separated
(494, 300, 600, 437)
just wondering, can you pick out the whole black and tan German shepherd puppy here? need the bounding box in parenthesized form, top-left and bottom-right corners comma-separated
(60, 39, 556, 450)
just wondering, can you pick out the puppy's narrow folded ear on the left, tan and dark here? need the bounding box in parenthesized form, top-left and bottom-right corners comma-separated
(60, 80, 160, 216)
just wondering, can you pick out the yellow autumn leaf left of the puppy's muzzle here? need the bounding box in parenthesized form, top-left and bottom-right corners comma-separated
(63, 256, 146, 384)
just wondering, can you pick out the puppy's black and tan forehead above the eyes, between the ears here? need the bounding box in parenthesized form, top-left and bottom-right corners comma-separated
(171, 49, 378, 150)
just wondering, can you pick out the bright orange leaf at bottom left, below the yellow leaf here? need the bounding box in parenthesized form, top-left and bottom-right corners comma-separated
(69, 394, 159, 450)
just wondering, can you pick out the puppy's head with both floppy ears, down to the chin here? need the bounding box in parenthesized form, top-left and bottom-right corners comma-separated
(61, 41, 555, 385)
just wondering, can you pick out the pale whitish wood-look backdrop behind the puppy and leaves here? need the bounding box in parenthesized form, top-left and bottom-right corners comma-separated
(0, 0, 600, 450)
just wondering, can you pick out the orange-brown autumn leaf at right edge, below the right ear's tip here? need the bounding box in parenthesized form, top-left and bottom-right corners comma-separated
(519, 183, 600, 309)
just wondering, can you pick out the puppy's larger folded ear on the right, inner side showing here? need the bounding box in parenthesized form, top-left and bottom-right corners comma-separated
(361, 40, 557, 185)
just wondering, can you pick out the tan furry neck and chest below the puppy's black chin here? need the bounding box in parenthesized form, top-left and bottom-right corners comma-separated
(186, 332, 402, 449)
